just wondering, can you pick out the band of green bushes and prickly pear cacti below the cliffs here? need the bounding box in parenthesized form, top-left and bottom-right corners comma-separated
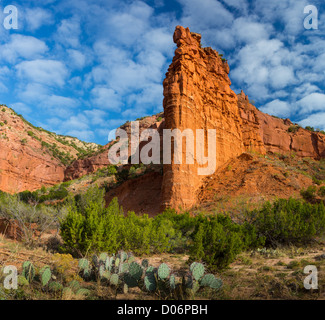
(0, 178, 325, 299)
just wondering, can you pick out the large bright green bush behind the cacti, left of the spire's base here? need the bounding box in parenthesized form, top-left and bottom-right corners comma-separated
(61, 186, 181, 255)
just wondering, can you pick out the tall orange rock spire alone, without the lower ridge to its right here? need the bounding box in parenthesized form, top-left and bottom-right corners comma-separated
(162, 26, 245, 208)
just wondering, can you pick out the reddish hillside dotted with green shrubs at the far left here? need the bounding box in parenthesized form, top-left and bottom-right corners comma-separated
(0, 105, 100, 193)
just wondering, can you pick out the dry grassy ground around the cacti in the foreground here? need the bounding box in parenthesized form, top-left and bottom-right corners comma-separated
(0, 232, 325, 300)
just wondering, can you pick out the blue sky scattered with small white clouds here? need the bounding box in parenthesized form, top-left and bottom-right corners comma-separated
(0, 0, 325, 144)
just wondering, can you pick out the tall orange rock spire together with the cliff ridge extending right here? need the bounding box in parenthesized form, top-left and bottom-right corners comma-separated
(162, 26, 325, 209)
